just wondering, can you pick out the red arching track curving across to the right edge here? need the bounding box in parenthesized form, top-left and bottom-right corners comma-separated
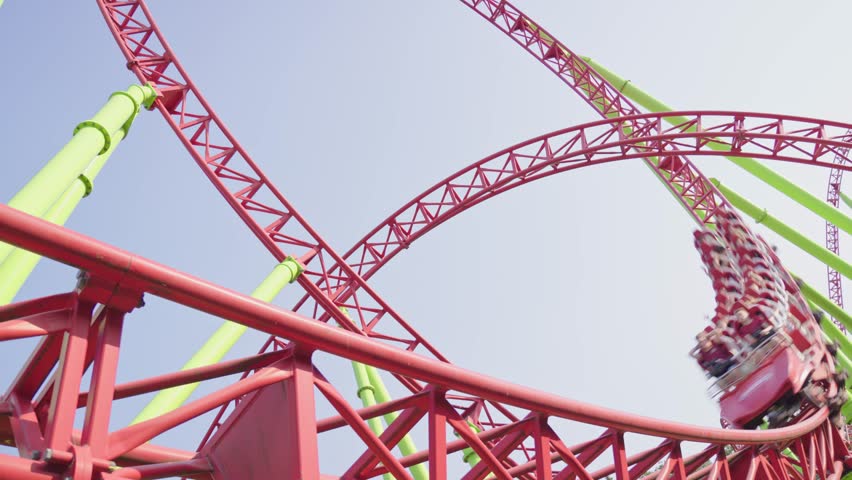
(299, 112, 852, 300)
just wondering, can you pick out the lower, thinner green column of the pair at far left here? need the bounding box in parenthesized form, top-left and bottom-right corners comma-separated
(0, 130, 125, 305)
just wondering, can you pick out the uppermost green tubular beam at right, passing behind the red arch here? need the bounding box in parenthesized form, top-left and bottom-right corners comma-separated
(582, 57, 852, 234)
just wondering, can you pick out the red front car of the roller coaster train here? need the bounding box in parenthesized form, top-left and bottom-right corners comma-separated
(711, 330, 831, 429)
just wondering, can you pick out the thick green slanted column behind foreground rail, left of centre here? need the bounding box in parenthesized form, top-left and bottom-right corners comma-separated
(131, 257, 303, 425)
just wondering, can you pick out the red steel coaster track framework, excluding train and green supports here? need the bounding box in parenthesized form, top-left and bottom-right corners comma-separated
(0, 0, 852, 480)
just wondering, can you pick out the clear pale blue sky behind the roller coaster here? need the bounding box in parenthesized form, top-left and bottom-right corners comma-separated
(0, 0, 852, 473)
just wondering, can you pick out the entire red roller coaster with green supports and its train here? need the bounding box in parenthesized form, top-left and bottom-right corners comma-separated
(0, 0, 852, 480)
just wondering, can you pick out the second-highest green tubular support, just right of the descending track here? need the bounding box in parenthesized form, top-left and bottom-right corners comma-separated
(710, 178, 852, 278)
